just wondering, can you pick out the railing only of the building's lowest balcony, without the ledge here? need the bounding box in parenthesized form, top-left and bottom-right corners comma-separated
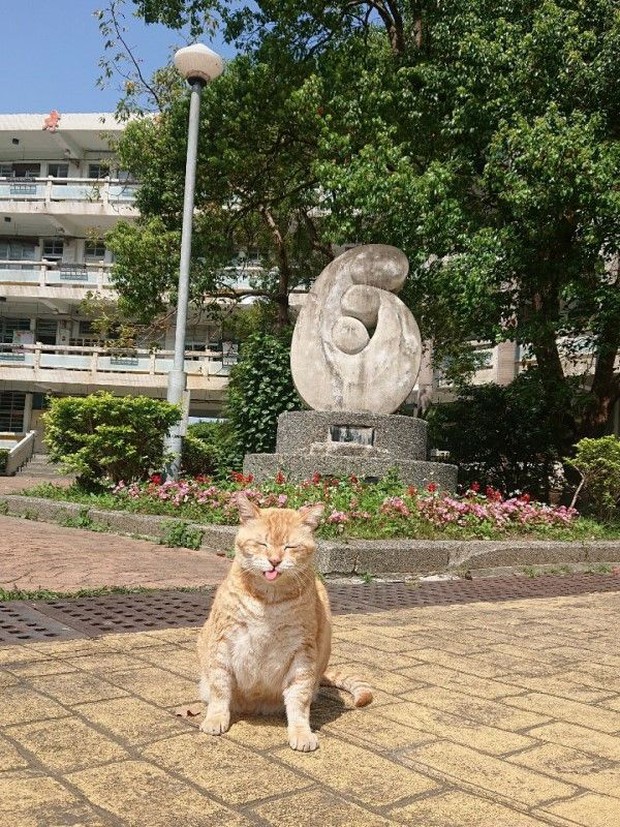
(0, 343, 235, 386)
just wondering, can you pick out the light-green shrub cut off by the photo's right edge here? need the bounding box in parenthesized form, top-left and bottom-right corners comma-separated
(566, 436, 620, 521)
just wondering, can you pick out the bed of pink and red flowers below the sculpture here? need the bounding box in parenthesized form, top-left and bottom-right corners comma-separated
(30, 473, 603, 540)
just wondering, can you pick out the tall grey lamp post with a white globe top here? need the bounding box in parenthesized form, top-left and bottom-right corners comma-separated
(165, 43, 224, 479)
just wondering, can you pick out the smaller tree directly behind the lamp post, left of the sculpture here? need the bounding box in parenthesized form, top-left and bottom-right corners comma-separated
(106, 42, 331, 329)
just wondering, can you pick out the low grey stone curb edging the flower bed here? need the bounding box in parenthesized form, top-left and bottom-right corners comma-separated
(0, 494, 620, 575)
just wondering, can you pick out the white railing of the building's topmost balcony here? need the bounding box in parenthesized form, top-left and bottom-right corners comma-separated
(0, 177, 138, 205)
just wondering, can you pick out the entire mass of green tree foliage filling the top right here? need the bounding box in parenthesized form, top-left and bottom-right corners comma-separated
(101, 0, 620, 440)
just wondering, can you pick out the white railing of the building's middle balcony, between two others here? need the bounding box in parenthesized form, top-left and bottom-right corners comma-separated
(0, 259, 114, 290)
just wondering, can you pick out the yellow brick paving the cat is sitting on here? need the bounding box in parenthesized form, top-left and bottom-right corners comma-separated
(0, 593, 620, 827)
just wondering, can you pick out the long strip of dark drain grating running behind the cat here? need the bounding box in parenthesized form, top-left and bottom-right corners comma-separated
(0, 574, 620, 644)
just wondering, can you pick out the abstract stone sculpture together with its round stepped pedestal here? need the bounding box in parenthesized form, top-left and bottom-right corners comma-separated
(243, 244, 457, 489)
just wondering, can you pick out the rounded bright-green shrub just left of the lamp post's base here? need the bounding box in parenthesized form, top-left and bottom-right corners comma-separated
(44, 393, 181, 488)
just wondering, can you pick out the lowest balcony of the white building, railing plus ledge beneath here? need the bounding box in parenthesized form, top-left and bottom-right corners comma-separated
(0, 343, 235, 402)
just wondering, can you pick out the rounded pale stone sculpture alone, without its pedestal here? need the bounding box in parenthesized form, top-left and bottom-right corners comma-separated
(291, 244, 422, 414)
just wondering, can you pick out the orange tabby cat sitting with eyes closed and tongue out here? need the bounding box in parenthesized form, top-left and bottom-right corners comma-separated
(198, 494, 372, 752)
